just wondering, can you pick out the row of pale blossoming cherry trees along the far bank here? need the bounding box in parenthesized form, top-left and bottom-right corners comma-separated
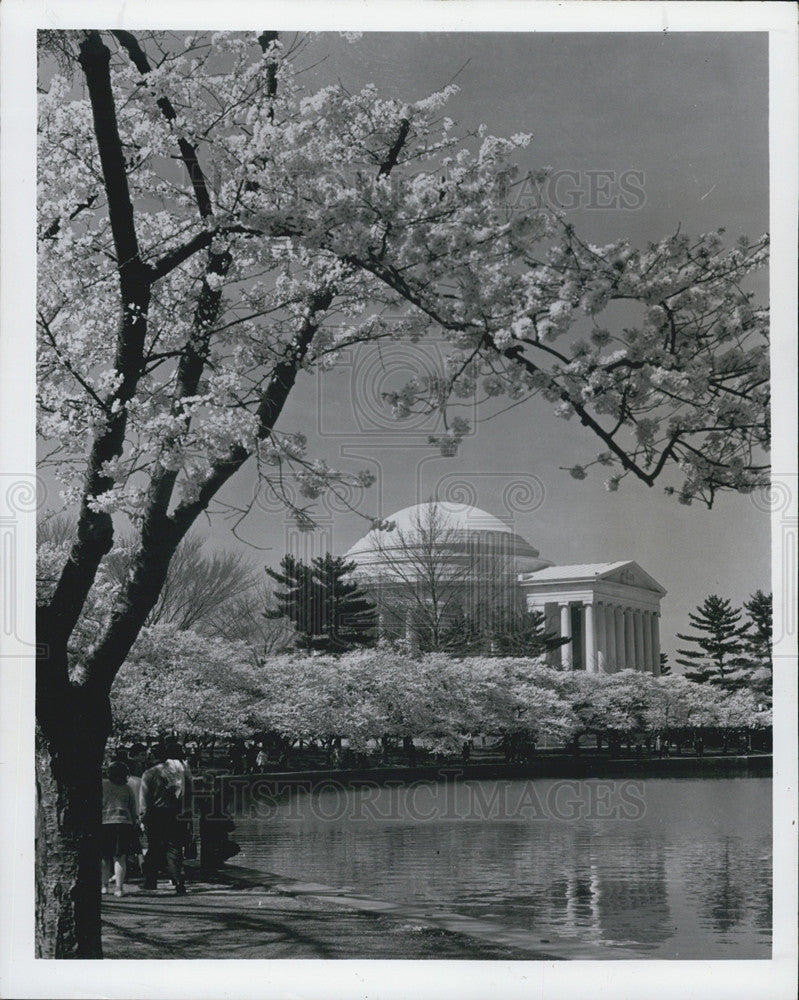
(113, 648, 771, 753)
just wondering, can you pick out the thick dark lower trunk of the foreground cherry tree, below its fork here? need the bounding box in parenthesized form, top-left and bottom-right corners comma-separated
(35, 644, 110, 958)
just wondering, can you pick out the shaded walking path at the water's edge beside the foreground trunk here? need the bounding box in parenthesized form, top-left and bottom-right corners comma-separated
(103, 868, 641, 961)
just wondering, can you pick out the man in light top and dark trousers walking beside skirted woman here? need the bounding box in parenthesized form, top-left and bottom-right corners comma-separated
(139, 740, 191, 896)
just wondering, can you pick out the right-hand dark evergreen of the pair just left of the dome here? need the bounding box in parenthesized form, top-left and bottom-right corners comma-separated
(312, 552, 377, 653)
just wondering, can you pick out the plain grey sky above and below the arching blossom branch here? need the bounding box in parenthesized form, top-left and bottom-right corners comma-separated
(191, 32, 771, 660)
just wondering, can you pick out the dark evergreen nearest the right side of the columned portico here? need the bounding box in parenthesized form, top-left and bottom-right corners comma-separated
(677, 594, 749, 687)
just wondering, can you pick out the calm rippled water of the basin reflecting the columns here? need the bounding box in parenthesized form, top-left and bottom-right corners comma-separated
(234, 778, 772, 959)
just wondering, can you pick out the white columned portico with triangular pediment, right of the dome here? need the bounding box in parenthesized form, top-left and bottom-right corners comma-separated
(518, 561, 666, 676)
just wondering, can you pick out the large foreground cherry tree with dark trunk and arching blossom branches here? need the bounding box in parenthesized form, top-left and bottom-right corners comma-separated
(36, 30, 768, 957)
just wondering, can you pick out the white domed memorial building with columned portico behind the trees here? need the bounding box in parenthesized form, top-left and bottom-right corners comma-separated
(345, 501, 666, 676)
